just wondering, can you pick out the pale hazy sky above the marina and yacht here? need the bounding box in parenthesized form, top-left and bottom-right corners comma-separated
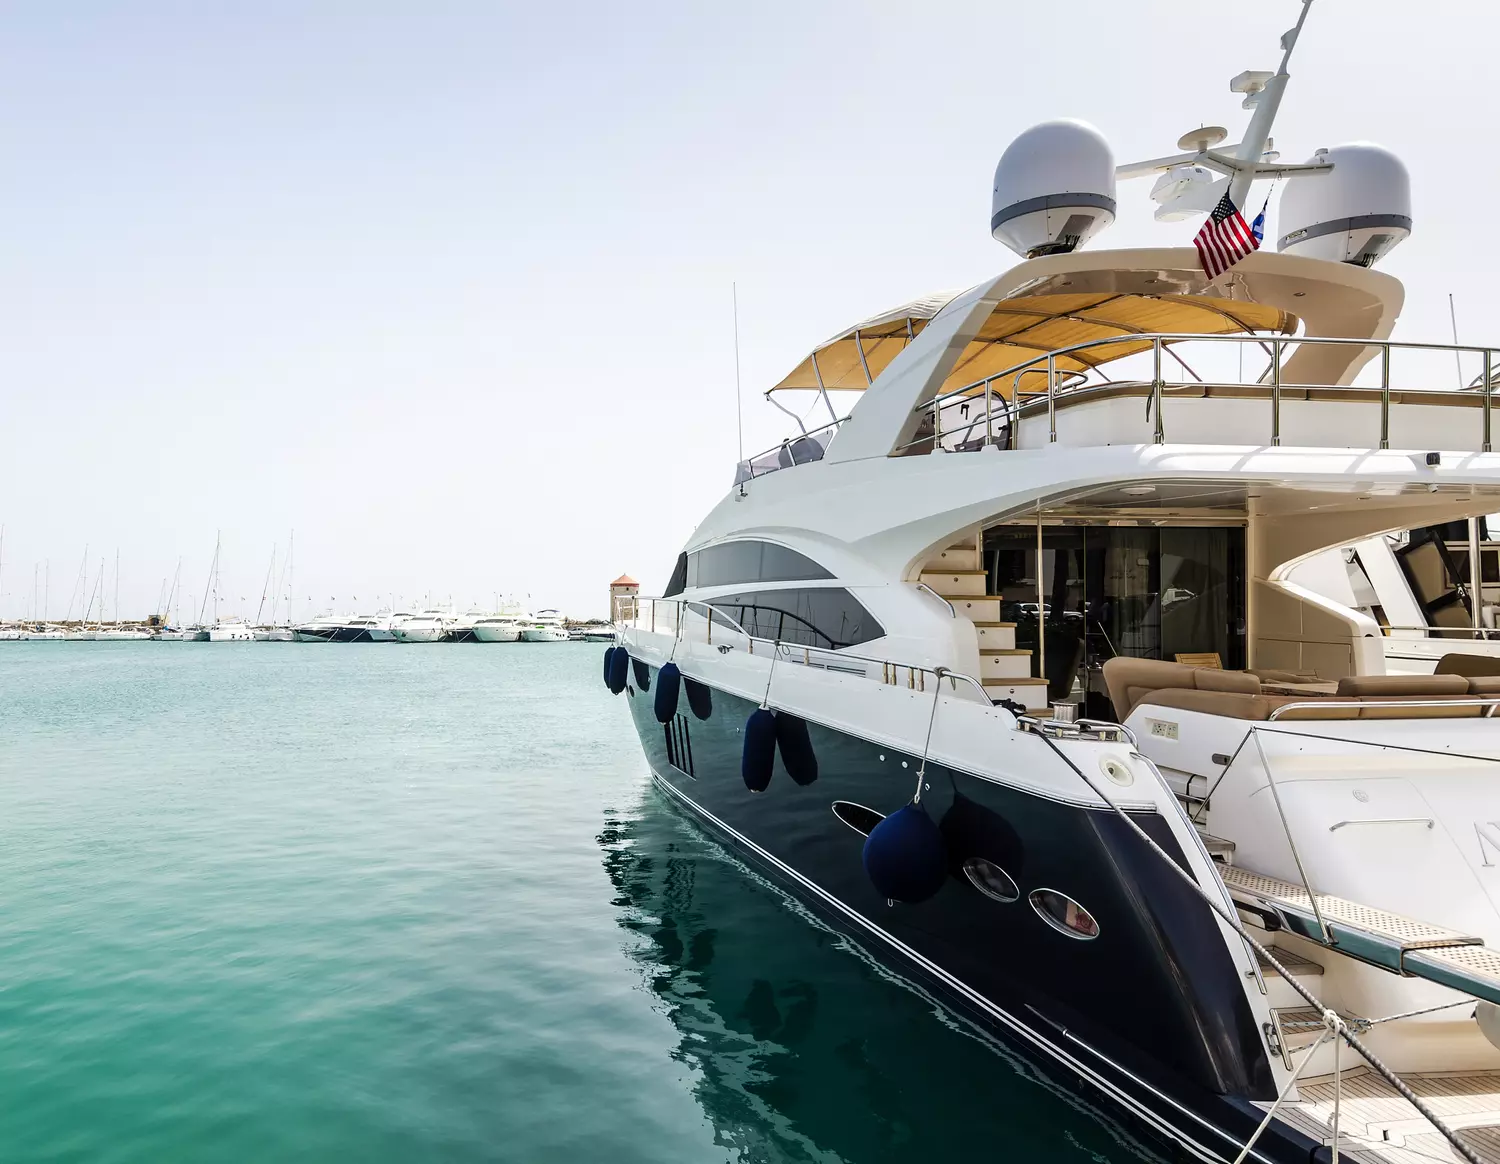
(0, 0, 1500, 617)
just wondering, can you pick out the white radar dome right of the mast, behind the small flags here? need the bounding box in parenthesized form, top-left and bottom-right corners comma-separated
(1277, 141, 1412, 267)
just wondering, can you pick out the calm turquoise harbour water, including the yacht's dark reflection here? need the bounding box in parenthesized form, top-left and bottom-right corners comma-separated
(0, 642, 1140, 1164)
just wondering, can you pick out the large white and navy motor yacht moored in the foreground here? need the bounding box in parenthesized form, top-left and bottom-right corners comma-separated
(606, 15, 1500, 1164)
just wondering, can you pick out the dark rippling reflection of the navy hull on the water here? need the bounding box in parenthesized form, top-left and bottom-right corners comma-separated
(599, 791, 1155, 1164)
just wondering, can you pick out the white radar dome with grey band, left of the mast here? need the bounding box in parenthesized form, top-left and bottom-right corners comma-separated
(990, 120, 1115, 258)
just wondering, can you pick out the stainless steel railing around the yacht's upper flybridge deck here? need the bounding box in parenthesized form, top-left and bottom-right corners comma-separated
(897, 332, 1500, 453)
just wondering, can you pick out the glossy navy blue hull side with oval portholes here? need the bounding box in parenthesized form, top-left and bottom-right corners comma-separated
(615, 662, 1326, 1164)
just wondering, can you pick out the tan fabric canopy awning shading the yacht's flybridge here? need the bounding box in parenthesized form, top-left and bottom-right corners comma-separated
(771, 291, 1299, 395)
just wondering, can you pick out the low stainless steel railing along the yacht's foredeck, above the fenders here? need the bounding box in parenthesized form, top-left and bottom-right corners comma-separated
(617, 597, 993, 707)
